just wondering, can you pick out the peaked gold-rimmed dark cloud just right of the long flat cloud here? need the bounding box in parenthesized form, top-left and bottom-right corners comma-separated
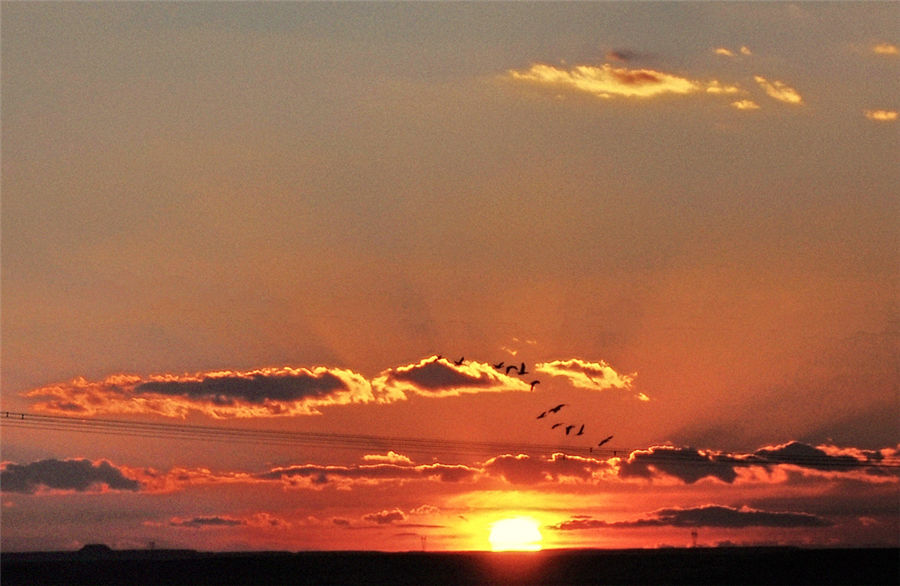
(372, 357, 530, 397)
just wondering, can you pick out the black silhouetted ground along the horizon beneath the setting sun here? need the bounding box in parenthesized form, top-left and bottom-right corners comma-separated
(0, 546, 900, 586)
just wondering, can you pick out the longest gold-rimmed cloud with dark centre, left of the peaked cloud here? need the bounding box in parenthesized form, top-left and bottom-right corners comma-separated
(24, 367, 378, 418)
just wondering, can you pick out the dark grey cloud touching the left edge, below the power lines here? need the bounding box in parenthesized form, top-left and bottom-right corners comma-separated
(0, 458, 141, 494)
